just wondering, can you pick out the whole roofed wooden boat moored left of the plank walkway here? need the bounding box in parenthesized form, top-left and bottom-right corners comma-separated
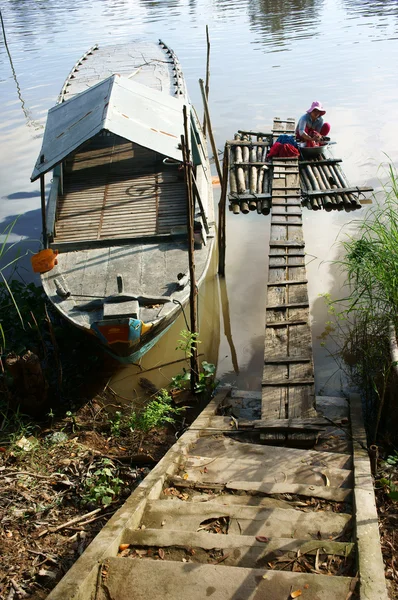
(31, 42, 214, 362)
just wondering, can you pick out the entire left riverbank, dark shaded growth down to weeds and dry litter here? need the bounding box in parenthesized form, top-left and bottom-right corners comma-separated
(0, 237, 215, 600)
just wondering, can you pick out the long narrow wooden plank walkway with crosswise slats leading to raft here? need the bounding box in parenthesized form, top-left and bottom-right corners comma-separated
(262, 119, 315, 419)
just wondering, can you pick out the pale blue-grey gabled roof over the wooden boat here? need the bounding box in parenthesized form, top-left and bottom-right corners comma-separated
(31, 75, 189, 181)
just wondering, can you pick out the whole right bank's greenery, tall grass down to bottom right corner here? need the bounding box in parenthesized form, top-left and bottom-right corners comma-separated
(323, 164, 398, 598)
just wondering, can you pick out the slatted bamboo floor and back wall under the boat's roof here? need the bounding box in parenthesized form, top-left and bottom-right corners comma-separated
(55, 135, 186, 242)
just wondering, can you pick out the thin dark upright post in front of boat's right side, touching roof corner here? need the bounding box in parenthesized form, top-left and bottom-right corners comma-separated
(181, 106, 199, 394)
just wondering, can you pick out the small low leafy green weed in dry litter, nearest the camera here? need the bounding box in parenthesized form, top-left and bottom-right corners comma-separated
(83, 458, 123, 506)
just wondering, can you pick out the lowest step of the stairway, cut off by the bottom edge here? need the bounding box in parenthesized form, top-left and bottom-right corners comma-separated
(96, 558, 353, 600)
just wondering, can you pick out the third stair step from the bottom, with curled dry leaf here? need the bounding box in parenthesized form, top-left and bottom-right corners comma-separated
(141, 500, 351, 543)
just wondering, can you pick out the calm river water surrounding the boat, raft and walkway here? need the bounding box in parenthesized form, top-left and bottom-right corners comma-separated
(0, 0, 398, 398)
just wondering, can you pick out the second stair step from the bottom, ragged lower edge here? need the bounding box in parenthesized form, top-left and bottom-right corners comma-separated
(122, 528, 355, 568)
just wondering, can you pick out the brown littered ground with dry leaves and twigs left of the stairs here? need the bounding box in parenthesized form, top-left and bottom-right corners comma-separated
(0, 386, 182, 600)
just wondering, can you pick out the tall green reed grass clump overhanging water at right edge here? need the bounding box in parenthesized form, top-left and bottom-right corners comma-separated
(332, 164, 398, 443)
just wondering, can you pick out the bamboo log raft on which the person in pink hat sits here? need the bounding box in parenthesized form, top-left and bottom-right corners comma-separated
(226, 119, 373, 215)
